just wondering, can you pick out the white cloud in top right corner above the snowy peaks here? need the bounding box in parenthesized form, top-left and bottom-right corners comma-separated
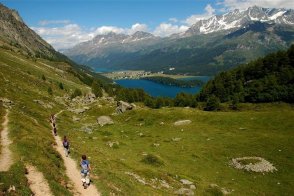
(218, 0, 294, 10)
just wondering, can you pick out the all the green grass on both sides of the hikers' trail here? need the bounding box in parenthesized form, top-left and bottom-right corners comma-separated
(0, 46, 294, 195)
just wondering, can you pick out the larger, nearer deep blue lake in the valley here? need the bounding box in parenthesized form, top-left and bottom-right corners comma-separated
(115, 79, 207, 98)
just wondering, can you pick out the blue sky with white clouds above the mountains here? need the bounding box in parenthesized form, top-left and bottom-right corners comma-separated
(0, 0, 294, 50)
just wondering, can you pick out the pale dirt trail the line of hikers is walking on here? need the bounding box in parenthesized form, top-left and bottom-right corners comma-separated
(54, 111, 100, 196)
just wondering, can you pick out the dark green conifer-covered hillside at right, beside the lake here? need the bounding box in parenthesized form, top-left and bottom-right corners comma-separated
(199, 45, 294, 103)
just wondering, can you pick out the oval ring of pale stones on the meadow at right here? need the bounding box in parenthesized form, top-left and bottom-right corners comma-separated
(231, 157, 277, 172)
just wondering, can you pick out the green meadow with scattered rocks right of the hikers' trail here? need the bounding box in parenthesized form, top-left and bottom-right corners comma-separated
(59, 103, 294, 195)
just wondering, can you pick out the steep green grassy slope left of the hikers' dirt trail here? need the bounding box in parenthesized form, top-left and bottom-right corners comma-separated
(0, 49, 87, 195)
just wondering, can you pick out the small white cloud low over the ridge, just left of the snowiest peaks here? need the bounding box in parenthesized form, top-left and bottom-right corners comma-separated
(153, 23, 189, 37)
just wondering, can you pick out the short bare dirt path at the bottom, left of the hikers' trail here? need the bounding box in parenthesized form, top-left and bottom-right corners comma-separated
(26, 165, 53, 196)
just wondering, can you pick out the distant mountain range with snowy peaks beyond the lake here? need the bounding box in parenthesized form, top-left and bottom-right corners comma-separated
(64, 6, 294, 75)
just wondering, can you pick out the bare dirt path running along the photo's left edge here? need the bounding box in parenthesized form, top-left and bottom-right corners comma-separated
(0, 110, 13, 171)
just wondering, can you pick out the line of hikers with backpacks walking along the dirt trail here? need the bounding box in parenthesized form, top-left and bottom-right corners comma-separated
(49, 114, 91, 189)
